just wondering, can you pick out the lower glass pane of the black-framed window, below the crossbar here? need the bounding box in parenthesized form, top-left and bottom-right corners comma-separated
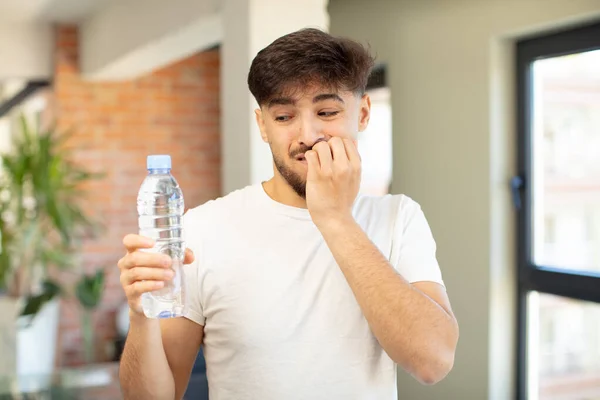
(527, 292, 600, 400)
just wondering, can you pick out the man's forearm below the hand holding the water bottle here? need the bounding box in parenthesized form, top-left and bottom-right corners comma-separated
(119, 314, 175, 400)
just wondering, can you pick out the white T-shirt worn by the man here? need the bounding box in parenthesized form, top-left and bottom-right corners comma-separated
(184, 184, 443, 400)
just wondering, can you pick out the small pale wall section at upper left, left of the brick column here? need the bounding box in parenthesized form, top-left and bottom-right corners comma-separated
(0, 22, 53, 81)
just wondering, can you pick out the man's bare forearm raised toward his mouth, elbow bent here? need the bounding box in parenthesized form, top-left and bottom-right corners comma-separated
(320, 220, 458, 382)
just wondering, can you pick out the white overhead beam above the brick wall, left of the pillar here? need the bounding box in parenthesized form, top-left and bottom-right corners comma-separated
(81, 0, 222, 80)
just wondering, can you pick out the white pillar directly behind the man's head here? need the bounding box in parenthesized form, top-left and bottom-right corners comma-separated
(221, 0, 329, 194)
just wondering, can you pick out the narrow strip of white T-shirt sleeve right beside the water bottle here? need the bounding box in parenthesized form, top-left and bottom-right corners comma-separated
(183, 210, 206, 325)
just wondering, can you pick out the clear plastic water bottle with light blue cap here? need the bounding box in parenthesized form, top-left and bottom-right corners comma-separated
(137, 155, 185, 318)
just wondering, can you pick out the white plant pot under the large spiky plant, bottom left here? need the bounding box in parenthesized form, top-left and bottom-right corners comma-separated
(0, 297, 59, 392)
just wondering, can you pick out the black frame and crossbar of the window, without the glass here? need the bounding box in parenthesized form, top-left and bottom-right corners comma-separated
(511, 21, 600, 400)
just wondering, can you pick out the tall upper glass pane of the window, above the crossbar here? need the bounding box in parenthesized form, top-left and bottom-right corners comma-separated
(532, 50, 600, 271)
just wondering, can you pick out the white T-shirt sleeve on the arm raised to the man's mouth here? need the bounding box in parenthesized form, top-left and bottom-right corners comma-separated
(390, 196, 444, 286)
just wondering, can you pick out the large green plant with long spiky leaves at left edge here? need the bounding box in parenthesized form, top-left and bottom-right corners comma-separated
(0, 116, 102, 316)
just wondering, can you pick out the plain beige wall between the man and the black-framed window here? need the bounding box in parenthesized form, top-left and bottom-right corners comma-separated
(329, 0, 600, 400)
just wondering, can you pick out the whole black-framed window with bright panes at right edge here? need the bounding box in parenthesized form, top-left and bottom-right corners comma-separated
(513, 24, 600, 400)
